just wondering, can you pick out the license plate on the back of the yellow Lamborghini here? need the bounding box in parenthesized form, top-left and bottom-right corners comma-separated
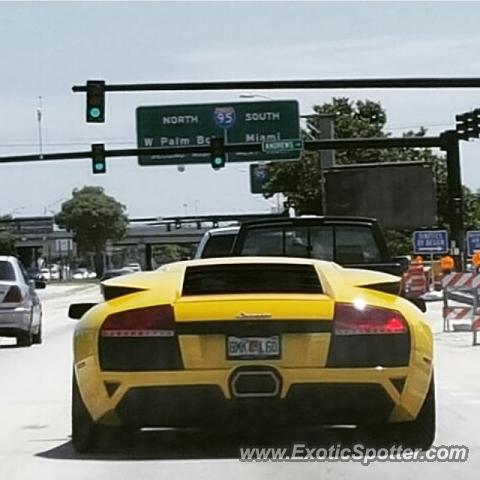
(227, 335, 280, 359)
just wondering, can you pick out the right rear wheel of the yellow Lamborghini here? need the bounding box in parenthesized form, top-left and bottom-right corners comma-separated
(376, 374, 436, 450)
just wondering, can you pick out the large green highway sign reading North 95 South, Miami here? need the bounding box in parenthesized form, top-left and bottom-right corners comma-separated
(136, 100, 301, 165)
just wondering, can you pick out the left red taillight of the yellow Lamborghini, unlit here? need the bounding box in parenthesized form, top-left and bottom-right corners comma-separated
(100, 305, 175, 337)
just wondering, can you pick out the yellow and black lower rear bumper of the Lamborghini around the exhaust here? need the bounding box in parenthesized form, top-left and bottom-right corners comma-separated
(76, 356, 431, 428)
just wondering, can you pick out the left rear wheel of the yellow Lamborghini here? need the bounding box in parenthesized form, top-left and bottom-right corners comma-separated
(72, 373, 130, 453)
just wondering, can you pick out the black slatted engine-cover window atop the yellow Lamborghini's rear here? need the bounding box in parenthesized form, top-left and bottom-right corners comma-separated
(182, 263, 322, 296)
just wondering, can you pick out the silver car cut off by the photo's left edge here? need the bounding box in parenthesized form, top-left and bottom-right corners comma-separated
(0, 256, 45, 347)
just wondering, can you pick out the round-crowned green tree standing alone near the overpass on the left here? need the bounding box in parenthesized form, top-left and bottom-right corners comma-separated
(55, 186, 128, 276)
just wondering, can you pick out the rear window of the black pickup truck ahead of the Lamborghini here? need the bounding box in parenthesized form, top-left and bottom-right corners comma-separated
(240, 225, 382, 264)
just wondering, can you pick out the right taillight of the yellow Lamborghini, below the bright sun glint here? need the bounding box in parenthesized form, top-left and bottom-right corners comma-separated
(334, 303, 407, 335)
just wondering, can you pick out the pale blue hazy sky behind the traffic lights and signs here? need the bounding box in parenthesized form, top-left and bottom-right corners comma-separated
(0, 1, 480, 217)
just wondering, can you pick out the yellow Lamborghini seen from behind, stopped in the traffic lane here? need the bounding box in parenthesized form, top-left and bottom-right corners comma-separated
(70, 257, 435, 451)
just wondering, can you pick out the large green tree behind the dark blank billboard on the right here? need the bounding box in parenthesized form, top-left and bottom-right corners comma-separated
(265, 98, 480, 255)
